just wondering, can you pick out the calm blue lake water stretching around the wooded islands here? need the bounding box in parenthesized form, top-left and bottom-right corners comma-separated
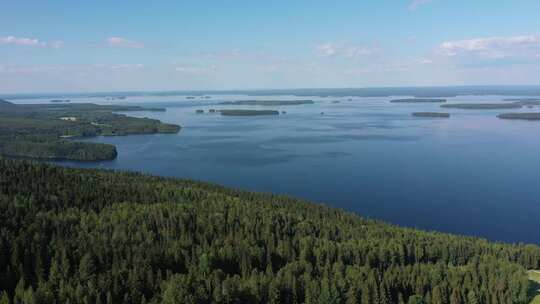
(22, 96, 540, 244)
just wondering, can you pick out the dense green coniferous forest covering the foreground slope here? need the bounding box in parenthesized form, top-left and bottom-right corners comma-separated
(0, 160, 540, 304)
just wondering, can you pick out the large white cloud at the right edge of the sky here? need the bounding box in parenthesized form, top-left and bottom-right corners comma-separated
(438, 35, 540, 59)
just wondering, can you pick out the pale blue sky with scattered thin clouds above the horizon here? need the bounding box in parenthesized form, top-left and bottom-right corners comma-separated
(0, 0, 540, 93)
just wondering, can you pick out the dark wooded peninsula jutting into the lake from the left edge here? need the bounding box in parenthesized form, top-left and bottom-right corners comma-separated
(0, 100, 180, 161)
